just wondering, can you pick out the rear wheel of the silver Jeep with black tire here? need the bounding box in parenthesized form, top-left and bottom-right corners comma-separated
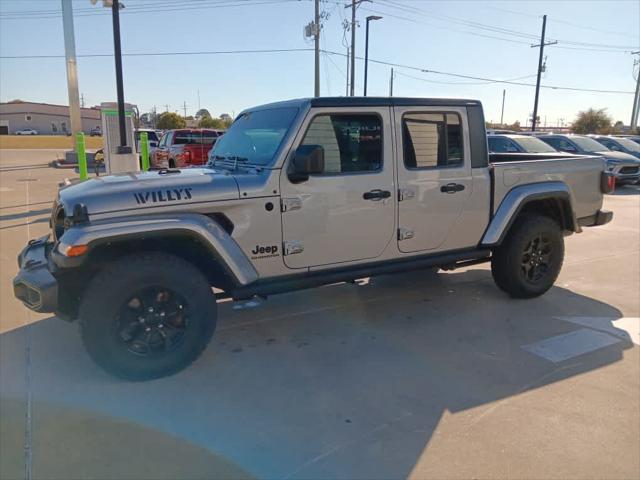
(491, 214, 564, 298)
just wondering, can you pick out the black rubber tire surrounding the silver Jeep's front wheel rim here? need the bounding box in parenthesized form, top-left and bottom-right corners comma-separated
(79, 252, 217, 381)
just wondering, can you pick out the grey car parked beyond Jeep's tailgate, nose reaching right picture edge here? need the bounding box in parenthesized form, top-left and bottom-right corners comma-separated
(537, 134, 640, 185)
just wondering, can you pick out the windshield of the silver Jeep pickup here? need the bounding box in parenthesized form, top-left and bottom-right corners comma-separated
(210, 107, 298, 166)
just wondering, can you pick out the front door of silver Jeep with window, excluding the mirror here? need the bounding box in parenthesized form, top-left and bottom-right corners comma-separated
(280, 107, 396, 268)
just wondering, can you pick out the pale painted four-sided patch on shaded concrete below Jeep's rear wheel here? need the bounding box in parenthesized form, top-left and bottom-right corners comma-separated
(521, 328, 622, 363)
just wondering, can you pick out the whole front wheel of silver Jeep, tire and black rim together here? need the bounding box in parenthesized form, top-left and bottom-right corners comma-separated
(80, 253, 216, 380)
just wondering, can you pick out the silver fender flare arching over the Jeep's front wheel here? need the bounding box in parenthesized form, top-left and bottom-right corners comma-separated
(56, 213, 258, 285)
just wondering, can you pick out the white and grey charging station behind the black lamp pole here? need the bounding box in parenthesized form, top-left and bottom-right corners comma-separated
(100, 102, 140, 174)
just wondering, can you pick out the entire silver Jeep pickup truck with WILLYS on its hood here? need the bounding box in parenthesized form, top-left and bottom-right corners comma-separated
(14, 97, 613, 380)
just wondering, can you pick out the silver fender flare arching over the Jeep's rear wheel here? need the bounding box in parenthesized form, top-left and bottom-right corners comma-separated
(480, 182, 581, 247)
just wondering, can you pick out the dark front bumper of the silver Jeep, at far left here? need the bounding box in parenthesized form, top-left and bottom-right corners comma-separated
(13, 235, 58, 313)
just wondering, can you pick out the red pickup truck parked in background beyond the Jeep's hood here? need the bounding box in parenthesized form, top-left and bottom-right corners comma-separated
(151, 128, 220, 168)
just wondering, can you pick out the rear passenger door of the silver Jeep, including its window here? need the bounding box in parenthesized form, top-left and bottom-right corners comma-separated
(394, 107, 473, 253)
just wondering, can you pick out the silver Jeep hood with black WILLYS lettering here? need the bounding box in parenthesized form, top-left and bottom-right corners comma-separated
(59, 168, 240, 215)
